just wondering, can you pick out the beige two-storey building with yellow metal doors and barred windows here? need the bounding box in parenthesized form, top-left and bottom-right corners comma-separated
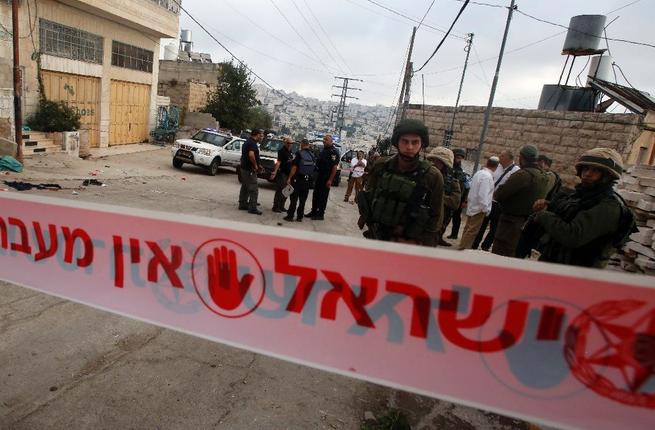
(0, 0, 179, 147)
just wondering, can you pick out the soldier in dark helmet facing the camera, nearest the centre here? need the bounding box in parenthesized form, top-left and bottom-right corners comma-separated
(357, 119, 443, 246)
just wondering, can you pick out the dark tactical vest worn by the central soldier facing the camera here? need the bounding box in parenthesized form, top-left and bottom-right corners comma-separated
(371, 160, 434, 240)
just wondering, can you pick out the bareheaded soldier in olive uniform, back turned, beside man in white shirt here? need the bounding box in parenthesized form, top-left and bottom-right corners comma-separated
(491, 145, 548, 257)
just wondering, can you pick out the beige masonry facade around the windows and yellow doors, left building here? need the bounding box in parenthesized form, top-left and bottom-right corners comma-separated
(0, 0, 179, 147)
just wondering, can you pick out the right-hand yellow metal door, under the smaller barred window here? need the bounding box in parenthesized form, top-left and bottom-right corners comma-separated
(109, 80, 150, 145)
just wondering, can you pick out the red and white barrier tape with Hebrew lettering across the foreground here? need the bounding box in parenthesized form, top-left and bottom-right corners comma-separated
(0, 194, 655, 429)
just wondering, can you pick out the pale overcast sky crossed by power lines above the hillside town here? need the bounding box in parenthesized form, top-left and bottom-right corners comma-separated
(162, 0, 655, 112)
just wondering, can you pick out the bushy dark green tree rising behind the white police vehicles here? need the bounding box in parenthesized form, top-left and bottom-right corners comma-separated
(203, 62, 260, 130)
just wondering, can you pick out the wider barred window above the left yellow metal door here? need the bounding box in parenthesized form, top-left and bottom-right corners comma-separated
(39, 18, 103, 64)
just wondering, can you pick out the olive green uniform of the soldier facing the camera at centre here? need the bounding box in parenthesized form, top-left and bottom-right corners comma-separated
(358, 155, 444, 246)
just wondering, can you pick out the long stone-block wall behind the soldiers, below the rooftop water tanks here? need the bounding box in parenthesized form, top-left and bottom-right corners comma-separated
(407, 105, 643, 185)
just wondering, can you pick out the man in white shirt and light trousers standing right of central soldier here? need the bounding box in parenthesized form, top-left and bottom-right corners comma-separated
(459, 157, 499, 249)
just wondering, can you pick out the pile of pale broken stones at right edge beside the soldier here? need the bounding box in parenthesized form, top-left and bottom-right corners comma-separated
(610, 166, 655, 276)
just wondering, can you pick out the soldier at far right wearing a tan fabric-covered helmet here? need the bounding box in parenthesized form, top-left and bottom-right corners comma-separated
(534, 148, 635, 268)
